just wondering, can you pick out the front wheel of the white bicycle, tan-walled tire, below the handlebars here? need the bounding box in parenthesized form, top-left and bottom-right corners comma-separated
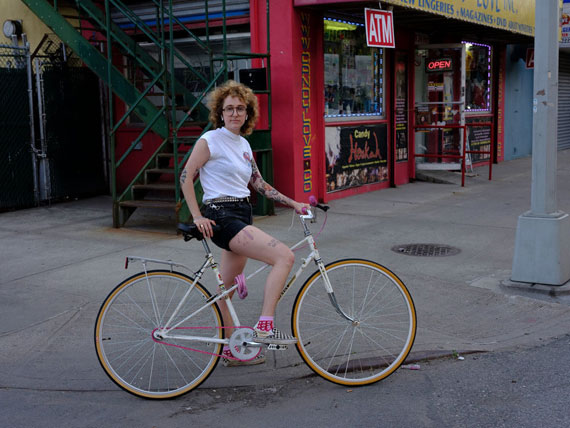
(291, 259, 416, 386)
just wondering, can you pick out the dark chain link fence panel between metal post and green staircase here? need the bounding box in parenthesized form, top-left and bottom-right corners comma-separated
(34, 35, 108, 200)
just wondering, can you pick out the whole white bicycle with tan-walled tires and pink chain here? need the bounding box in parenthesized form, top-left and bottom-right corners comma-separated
(95, 203, 416, 399)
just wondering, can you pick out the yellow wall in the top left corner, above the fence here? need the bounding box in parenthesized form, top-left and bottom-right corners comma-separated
(0, 0, 77, 52)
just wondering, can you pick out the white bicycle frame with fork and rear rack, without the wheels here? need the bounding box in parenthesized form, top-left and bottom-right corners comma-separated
(126, 210, 355, 347)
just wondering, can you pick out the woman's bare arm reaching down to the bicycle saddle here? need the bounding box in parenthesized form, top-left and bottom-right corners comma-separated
(180, 138, 215, 237)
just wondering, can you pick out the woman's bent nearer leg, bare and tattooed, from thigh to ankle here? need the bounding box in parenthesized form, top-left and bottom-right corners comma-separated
(230, 226, 295, 317)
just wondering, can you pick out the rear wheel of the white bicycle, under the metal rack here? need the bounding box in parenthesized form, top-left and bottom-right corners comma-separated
(95, 270, 223, 399)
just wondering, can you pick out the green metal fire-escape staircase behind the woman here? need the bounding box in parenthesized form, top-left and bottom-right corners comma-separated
(21, 0, 273, 227)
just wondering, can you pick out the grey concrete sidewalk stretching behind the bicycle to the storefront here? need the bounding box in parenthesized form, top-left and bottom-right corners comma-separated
(0, 150, 570, 391)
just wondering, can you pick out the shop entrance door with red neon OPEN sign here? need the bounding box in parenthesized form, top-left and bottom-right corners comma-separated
(414, 44, 465, 170)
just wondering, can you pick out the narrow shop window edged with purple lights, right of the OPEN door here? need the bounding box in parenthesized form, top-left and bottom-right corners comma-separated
(463, 42, 491, 113)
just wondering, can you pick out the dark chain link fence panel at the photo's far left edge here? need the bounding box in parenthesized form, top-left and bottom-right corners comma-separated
(0, 45, 37, 210)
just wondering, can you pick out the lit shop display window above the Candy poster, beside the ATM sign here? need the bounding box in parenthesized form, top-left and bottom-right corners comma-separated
(324, 18, 384, 120)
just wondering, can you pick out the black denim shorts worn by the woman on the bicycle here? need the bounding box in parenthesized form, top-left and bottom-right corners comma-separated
(202, 201, 253, 251)
